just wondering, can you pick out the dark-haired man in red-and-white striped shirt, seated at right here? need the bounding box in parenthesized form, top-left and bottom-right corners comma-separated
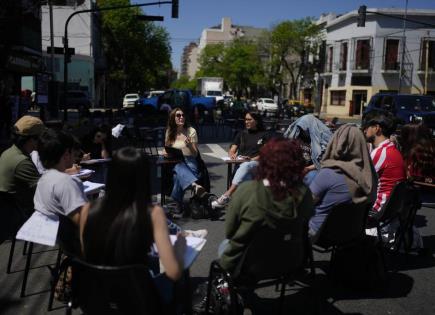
(364, 112, 406, 217)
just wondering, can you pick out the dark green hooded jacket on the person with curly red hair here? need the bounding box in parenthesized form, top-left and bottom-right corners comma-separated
(220, 181, 314, 272)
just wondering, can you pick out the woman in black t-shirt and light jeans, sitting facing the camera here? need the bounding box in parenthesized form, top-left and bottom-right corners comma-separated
(212, 112, 269, 208)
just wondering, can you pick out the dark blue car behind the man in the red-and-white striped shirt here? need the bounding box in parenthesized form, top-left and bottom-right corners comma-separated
(363, 93, 435, 135)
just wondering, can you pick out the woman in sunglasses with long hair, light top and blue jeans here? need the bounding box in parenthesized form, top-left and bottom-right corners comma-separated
(164, 107, 205, 212)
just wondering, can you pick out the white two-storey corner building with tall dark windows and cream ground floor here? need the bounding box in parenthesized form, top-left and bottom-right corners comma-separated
(321, 9, 435, 116)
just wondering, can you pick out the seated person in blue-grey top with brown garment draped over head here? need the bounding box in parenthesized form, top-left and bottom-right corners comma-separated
(309, 124, 377, 236)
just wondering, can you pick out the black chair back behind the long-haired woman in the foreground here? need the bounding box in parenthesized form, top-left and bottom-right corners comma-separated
(67, 258, 165, 315)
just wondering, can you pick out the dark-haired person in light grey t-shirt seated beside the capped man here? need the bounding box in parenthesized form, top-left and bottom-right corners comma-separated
(34, 130, 88, 225)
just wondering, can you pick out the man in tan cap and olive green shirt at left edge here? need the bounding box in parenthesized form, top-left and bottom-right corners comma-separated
(0, 116, 45, 219)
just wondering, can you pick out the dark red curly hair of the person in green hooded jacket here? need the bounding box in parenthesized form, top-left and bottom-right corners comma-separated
(256, 138, 305, 200)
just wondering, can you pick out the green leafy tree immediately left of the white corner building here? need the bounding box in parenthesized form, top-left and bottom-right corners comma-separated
(270, 18, 320, 98)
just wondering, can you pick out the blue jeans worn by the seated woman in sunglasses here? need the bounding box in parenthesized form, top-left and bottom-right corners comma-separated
(171, 156, 199, 203)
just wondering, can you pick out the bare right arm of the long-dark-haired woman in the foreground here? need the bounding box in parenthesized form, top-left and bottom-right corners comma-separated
(151, 206, 186, 280)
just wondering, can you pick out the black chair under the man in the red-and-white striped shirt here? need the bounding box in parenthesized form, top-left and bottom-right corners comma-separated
(367, 181, 421, 252)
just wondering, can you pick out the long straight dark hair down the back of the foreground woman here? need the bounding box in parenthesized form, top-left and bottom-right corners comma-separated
(83, 147, 153, 266)
